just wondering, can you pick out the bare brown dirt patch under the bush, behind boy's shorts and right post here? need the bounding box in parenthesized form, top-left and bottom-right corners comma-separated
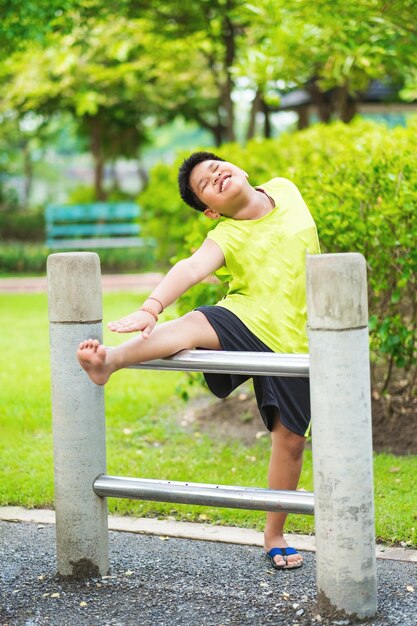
(181, 380, 417, 455)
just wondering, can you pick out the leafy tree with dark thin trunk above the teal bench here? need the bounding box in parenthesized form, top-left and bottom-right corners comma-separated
(2, 15, 198, 199)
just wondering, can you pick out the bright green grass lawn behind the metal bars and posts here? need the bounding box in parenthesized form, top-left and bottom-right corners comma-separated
(0, 293, 417, 545)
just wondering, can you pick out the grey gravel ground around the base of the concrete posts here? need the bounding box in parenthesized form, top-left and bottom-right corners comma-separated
(0, 522, 417, 626)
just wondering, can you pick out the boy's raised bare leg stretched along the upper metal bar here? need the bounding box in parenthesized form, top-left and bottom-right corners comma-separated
(77, 311, 220, 385)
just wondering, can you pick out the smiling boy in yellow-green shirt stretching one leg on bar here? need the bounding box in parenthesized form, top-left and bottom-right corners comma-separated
(78, 152, 319, 569)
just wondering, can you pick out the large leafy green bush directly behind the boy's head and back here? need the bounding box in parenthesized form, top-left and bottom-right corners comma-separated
(139, 120, 417, 388)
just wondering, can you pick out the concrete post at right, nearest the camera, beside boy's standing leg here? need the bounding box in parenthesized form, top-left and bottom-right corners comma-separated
(307, 253, 377, 618)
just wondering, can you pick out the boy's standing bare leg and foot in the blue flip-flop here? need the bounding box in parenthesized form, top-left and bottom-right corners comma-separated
(264, 419, 305, 566)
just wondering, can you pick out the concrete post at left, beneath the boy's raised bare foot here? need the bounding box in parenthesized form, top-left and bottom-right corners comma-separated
(47, 252, 109, 578)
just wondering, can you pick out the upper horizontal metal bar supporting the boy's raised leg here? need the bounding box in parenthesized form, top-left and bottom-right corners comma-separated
(130, 350, 310, 377)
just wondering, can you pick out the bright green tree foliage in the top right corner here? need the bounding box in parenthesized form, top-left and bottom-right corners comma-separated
(239, 0, 417, 127)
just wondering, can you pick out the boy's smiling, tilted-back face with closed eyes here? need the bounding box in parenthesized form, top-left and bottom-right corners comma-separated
(189, 161, 249, 217)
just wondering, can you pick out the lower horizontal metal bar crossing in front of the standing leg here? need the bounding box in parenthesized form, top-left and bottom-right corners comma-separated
(93, 474, 314, 515)
